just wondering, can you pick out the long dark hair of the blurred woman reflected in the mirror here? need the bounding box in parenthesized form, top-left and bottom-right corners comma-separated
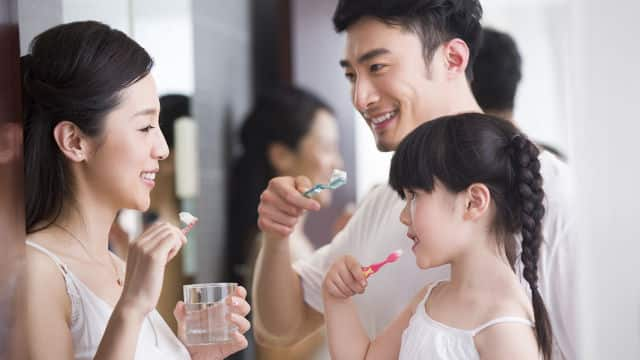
(226, 87, 333, 281)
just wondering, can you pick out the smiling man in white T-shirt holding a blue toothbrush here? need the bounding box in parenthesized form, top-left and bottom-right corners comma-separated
(253, 0, 575, 358)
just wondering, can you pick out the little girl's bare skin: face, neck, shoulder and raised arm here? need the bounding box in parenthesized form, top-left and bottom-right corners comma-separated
(323, 184, 539, 360)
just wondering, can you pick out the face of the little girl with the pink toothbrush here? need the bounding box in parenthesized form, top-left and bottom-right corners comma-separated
(400, 181, 468, 269)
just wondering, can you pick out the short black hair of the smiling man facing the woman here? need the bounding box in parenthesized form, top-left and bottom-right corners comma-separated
(333, 0, 482, 80)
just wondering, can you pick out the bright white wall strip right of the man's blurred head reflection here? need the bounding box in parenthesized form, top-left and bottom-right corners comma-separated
(482, 0, 568, 153)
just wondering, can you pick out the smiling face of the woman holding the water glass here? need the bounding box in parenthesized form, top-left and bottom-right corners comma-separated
(83, 75, 169, 211)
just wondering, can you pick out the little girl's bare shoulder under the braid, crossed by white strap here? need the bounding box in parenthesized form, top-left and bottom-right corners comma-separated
(474, 298, 539, 360)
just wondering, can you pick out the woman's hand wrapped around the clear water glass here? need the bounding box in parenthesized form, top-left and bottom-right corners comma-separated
(173, 286, 251, 360)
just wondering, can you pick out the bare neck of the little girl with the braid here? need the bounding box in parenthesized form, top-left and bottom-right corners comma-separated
(451, 238, 517, 289)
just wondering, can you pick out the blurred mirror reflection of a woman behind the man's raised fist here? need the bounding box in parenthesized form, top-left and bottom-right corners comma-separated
(227, 88, 342, 359)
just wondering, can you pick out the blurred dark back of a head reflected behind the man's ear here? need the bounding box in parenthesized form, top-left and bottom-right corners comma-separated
(471, 28, 522, 111)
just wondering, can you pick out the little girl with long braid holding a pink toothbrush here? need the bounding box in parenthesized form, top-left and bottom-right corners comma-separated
(323, 114, 552, 360)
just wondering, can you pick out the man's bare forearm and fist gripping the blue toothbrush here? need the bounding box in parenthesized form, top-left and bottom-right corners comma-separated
(253, 177, 322, 346)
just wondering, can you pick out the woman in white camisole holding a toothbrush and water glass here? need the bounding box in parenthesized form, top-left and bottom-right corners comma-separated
(22, 22, 249, 360)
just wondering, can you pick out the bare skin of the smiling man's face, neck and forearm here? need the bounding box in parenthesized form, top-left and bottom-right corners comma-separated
(253, 18, 481, 345)
